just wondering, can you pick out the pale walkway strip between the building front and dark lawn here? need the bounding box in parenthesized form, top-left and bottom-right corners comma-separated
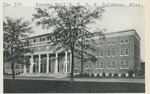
(4, 74, 145, 83)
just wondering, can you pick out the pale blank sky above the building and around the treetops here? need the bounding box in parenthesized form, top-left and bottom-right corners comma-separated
(3, 6, 145, 60)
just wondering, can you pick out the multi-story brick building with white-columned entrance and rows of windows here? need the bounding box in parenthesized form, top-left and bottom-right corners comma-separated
(4, 29, 141, 74)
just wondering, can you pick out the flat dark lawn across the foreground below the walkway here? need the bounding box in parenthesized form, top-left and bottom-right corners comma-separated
(4, 79, 145, 93)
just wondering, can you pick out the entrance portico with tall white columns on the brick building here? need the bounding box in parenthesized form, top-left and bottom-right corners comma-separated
(24, 51, 71, 73)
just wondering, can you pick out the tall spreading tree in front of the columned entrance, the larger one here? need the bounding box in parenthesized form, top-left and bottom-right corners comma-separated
(32, 6, 104, 83)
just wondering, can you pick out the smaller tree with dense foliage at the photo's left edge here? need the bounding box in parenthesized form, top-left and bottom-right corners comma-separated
(3, 17, 33, 80)
